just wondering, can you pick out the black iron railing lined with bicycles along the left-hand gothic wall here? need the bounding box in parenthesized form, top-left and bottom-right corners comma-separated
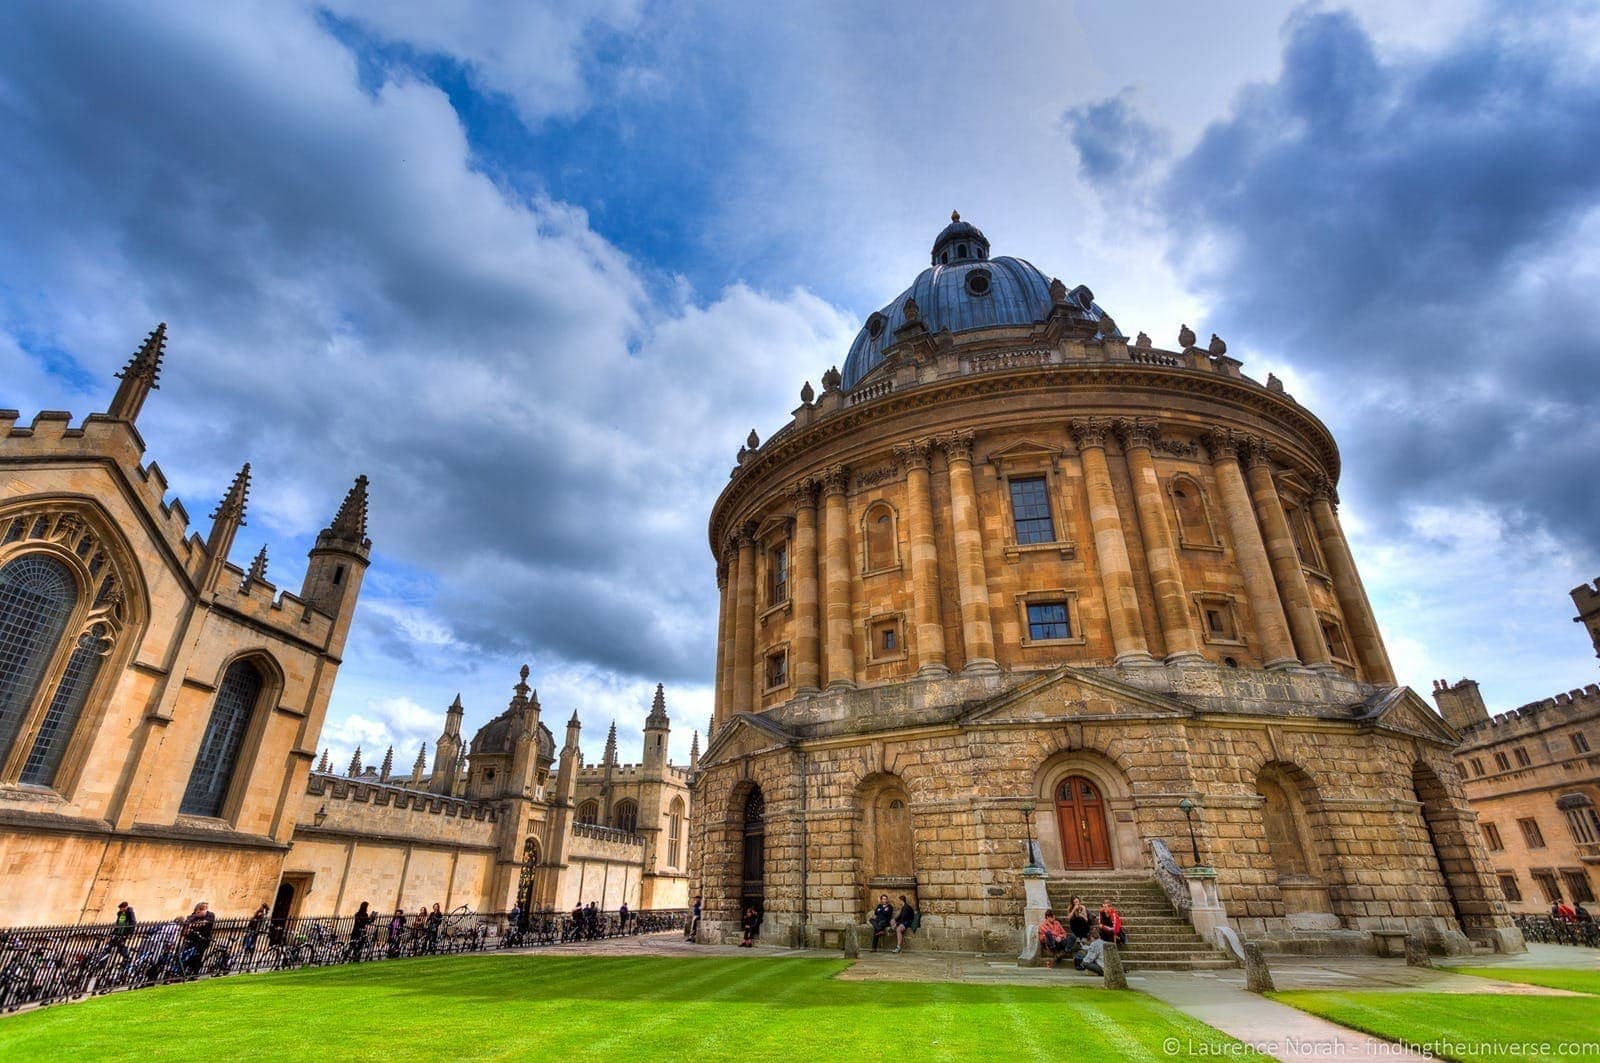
(0, 908, 688, 1012)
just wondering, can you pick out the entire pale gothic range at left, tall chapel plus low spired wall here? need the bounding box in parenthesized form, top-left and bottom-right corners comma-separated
(0, 325, 690, 925)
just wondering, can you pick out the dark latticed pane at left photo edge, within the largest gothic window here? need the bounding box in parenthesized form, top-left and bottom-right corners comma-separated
(0, 554, 78, 760)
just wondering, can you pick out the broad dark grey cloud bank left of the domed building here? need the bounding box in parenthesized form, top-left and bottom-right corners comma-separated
(0, 5, 840, 682)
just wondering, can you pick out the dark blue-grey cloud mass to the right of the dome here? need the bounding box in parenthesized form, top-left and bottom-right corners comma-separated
(1145, 6, 1600, 559)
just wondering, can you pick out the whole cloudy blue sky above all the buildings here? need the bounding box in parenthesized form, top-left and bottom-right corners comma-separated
(0, 0, 1600, 764)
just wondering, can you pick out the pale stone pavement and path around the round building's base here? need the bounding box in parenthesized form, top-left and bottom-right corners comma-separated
(505, 935, 1600, 1063)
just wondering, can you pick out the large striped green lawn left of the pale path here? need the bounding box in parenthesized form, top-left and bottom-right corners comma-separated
(0, 956, 1234, 1063)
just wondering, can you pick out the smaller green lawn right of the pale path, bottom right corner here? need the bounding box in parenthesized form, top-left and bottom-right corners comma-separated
(1272, 967, 1600, 1061)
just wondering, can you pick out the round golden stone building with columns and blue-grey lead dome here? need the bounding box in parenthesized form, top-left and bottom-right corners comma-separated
(693, 216, 1520, 962)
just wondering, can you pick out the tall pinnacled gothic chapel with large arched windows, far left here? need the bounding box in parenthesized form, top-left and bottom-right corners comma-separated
(0, 325, 371, 924)
